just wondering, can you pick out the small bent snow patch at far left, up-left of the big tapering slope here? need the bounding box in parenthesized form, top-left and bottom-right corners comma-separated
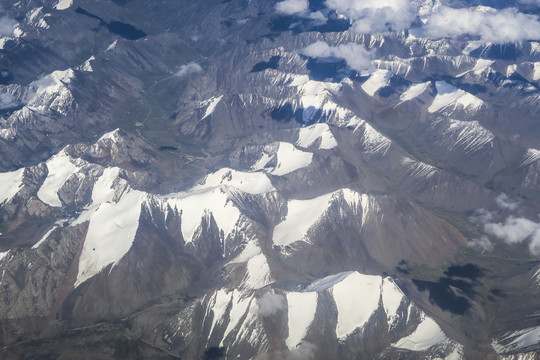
(37, 150, 80, 206)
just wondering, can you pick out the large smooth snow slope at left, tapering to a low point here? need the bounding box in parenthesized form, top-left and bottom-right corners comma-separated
(75, 190, 145, 287)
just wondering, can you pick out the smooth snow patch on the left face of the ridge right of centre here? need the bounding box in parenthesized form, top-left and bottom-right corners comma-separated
(272, 193, 333, 246)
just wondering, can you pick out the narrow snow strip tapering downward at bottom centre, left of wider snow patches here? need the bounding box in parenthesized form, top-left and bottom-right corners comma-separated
(285, 292, 318, 350)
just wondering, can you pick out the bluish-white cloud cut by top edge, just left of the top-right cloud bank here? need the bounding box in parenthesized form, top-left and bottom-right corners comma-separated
(326, 0, 418, 34)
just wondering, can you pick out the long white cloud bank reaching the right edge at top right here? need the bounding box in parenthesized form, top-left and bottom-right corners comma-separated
(425, 6, 540, 43)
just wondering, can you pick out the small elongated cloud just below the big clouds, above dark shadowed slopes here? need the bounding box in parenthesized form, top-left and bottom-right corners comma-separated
(302, 41, 373, 72)
